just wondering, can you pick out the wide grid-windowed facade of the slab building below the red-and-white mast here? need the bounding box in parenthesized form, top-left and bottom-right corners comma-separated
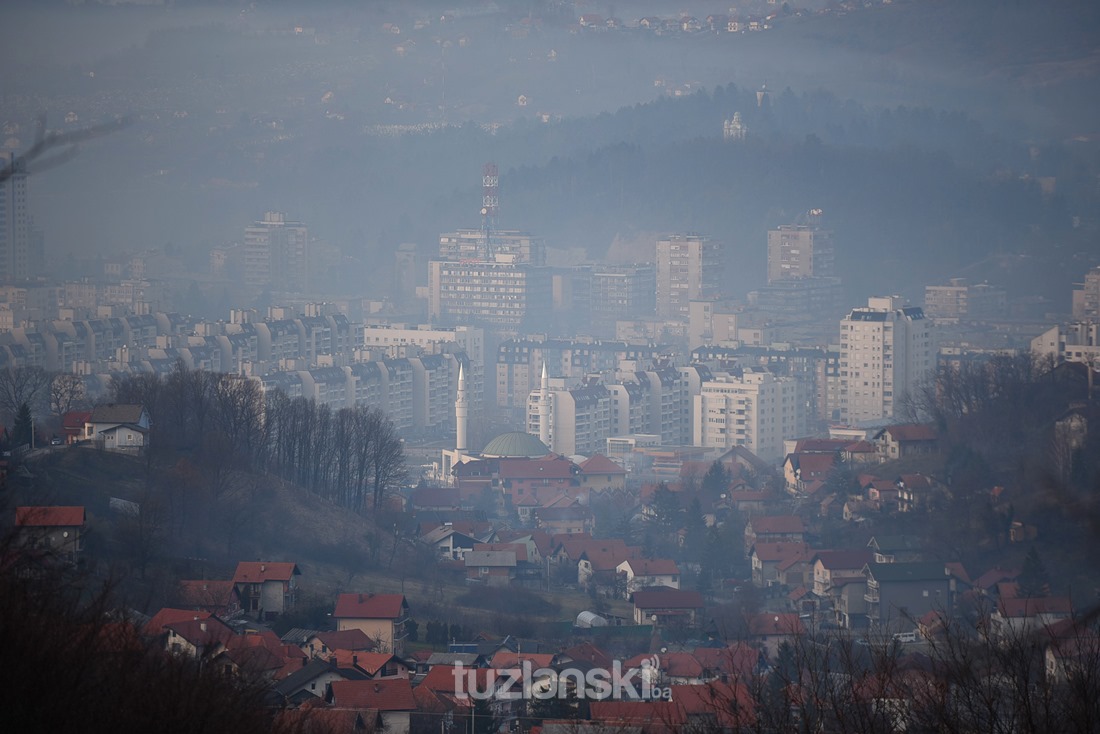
(428, 255, 553, 335)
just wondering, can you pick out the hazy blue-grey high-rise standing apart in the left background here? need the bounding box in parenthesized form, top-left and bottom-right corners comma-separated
(243, 211, 309, 292)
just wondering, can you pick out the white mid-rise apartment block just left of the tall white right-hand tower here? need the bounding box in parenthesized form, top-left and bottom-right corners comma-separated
(692, 368, 810, 460)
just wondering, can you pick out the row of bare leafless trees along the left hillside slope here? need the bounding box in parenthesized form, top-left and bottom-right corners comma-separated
(110, 362, 406, 512)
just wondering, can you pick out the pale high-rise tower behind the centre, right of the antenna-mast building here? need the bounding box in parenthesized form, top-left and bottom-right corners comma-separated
(657, 234, 722, 321)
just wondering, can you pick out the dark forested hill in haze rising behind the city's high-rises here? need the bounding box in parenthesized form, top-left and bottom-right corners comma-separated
(413, 86, 1097, 303)
